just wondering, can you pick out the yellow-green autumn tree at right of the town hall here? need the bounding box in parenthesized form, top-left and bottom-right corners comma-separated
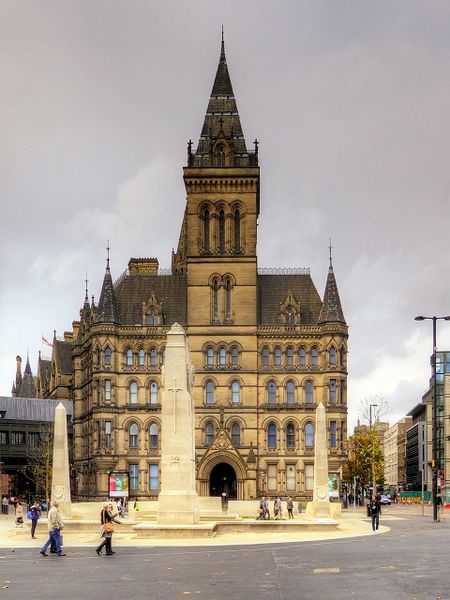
(342, 427, 384, 488)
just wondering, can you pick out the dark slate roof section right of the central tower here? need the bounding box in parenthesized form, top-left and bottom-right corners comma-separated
(258, 274, 322, 325)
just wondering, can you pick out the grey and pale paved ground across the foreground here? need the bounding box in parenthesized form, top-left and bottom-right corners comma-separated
(0, 506, 450, 600)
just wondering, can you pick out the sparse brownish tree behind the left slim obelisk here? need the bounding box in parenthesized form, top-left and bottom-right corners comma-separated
(20, 423, 53, 501)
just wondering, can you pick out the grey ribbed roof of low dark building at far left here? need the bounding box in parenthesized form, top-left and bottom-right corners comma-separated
(0, 396, 73, 421)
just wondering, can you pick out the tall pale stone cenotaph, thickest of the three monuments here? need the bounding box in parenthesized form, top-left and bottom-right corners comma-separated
(158, 323, 199, 525)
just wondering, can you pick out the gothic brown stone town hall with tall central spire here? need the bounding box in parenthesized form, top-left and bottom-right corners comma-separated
(38, 41, 348, 500)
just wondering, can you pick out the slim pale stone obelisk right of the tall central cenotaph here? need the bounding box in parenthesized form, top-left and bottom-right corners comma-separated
(307, 403, 331, 518)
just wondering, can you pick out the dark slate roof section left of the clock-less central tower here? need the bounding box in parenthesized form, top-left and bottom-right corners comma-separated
(114, 275, 187, 327)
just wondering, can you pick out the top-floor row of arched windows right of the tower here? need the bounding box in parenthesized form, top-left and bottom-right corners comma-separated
(261, 346, 345, 368)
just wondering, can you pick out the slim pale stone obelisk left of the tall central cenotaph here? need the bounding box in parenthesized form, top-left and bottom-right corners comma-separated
(52, 402, 72, 518)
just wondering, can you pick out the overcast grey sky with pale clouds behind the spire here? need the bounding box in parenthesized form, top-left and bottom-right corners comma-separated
(0, 0, 450, 426)
